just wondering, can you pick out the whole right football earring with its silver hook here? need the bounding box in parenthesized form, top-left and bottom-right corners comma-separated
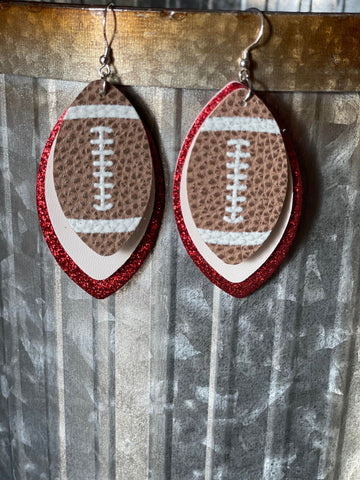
(173, 9, 302, 297)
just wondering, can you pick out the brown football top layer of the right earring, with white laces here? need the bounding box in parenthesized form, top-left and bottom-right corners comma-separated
(186, 82, 288, 265)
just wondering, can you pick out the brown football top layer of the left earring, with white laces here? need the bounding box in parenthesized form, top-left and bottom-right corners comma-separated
(54, 80, 153, 256)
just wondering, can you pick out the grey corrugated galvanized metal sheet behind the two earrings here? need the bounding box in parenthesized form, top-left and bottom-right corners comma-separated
(0, 0, 360, 480)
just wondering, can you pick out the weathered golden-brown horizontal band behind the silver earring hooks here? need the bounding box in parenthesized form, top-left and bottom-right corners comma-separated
(0, 2, 360, 91)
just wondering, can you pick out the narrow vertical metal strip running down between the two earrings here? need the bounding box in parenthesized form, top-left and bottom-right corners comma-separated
(145, 88, 181, 480)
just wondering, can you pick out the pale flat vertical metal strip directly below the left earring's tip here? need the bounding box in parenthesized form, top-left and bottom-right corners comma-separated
(115, 216, 151, 480)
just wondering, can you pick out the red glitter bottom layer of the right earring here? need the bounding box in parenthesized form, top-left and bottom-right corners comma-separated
(173, 82, 302, 298)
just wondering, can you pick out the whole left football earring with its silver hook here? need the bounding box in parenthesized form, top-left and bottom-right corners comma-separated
(36, 4, 164, 298)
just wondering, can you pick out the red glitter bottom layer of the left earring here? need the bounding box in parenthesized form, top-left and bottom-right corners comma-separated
(36, 111, 165, 298)
